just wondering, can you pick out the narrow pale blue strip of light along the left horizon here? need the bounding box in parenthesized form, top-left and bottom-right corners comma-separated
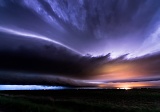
(0, 85, 65, 90)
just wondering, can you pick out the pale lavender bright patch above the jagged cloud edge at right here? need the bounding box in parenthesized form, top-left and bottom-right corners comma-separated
(93, 24, 160, 59)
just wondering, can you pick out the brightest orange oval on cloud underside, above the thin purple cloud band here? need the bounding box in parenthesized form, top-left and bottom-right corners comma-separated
(93, 63, 144, 80)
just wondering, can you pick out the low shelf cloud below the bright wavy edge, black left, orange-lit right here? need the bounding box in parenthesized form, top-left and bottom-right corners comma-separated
(0, 32, 160, 86)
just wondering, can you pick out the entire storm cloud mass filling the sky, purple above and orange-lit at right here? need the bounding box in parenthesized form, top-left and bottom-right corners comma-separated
(0, 0, 160, 87)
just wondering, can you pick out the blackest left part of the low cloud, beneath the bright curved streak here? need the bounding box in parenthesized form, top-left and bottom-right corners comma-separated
(0, 33, 83, 76)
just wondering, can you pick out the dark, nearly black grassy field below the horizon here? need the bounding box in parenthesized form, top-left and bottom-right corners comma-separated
(0, 89, 160, 112)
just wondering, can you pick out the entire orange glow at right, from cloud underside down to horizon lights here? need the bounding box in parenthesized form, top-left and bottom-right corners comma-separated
(88, 54, 160, 89)
